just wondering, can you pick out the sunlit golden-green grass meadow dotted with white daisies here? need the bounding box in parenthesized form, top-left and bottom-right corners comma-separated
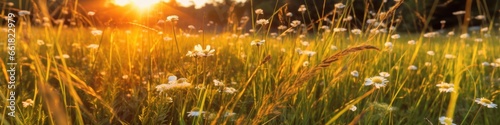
(0, 0, 500, 125)
